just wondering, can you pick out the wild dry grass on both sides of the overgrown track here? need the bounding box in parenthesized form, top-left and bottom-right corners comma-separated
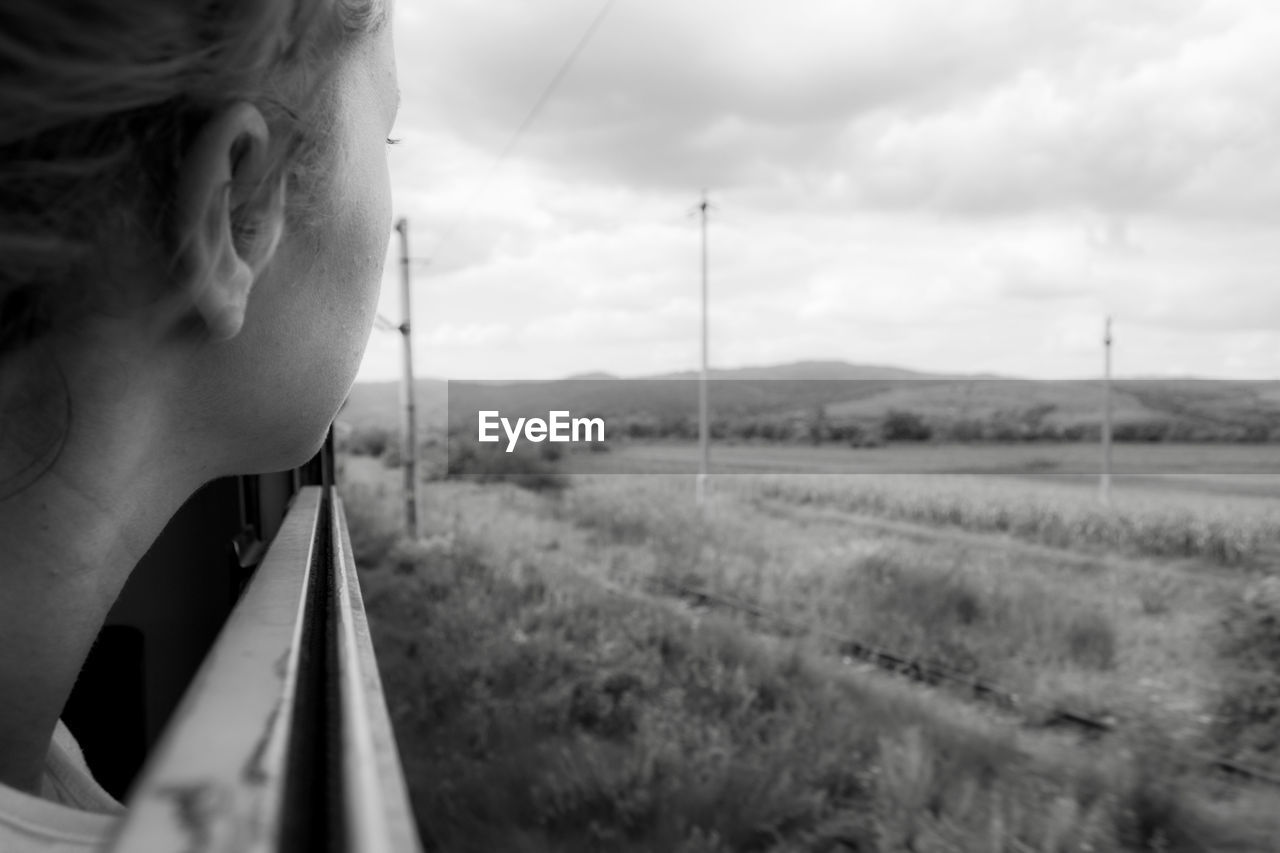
(337, 458, 1280, 853)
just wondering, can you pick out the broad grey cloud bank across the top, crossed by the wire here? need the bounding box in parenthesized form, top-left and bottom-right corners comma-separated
(394, 0, 1280, 215)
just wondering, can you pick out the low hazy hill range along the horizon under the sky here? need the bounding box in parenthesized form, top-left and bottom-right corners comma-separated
(338, 361, 1280, 435)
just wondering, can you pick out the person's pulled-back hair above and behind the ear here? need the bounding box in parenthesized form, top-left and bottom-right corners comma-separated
(0, 0, 385, 356)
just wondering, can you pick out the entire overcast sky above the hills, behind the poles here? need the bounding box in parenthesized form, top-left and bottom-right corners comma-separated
(361, 0, 1280, 379)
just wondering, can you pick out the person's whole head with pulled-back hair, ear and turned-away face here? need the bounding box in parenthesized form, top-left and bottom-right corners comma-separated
(0, 0, 397, 494)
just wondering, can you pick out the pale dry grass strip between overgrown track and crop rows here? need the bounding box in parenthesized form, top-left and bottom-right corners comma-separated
(559, 468, 1244, 736)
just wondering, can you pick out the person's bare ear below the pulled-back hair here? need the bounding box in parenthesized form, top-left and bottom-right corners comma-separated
(175, 102, 284, 341)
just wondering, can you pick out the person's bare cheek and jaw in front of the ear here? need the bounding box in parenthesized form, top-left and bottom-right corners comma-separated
(200, 119, 392, 471)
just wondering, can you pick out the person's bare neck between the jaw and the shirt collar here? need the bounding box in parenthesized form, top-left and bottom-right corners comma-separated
(0, 350, 202, 794)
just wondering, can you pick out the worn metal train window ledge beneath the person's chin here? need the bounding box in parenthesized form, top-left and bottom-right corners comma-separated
(110, 485, 421, 853)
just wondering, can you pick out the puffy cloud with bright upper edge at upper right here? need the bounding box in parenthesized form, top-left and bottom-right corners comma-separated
(839, 6, 1280, 219)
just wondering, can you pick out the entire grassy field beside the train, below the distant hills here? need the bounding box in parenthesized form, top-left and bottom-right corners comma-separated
(340, 447, 1280, 853)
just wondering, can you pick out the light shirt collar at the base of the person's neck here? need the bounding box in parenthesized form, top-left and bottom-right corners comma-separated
(0, 720, 124, 853)
